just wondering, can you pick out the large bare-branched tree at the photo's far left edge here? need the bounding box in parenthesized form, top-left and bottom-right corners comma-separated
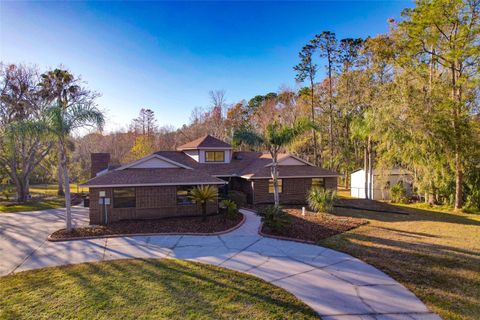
(0, 65, 52, 202)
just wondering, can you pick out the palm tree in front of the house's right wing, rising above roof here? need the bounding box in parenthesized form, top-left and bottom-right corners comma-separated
(233, 119, 316, 206)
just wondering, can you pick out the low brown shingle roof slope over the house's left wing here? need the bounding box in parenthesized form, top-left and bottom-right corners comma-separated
(83, 168, 225, 187)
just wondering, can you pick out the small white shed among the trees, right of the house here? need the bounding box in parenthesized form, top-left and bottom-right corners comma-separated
(350, 168, 413, 200)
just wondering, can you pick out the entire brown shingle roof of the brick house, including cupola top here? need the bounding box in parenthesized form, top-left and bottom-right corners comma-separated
(84, 135, 339, 187)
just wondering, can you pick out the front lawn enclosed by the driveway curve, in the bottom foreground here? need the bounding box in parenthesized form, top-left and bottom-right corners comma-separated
(0, 259, 319, 319)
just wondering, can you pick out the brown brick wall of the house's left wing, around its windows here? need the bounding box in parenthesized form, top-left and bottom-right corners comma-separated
(90, 186, 218, 224)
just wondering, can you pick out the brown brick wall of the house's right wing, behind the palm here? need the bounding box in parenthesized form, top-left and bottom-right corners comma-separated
(253, 177, 337, 204)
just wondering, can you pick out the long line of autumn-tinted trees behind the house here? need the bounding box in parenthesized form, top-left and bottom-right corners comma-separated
(0, 0, 480, 212)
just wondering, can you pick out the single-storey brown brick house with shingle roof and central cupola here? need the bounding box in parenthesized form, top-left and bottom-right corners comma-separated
(84, 135, 339, 224)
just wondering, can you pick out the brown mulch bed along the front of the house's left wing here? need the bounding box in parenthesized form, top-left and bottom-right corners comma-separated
(49, 213, 243, 240)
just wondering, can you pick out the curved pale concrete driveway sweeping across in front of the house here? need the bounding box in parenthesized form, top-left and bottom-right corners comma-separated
(0, 207, 440, 320)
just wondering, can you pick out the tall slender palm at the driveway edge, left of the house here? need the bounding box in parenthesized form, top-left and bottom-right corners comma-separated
(47, 104, 105, 232)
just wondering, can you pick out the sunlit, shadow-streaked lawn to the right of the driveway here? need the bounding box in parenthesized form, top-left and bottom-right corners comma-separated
(319, 204, 480, 320)
